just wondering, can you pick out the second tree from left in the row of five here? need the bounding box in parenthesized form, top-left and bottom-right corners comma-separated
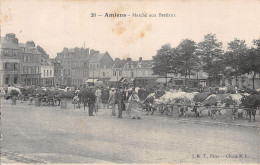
(176, 39, 199, 85)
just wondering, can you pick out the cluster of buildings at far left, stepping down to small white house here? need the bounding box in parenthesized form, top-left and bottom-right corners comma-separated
(0, 33, 55, 86)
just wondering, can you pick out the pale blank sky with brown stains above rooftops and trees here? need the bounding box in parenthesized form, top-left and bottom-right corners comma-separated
(0, 0, 260, 59)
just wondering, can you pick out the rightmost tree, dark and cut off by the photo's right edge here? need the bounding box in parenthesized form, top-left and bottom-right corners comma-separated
(242, 39, 260, 89)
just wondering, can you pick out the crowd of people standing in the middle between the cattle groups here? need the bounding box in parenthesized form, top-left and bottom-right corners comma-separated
(73, 86, 156, 119)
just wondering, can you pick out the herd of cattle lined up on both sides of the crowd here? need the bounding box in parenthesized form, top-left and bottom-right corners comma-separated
(0, 87, 259, 121)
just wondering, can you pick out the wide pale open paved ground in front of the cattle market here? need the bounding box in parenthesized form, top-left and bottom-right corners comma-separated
(1, 100, 260, 164)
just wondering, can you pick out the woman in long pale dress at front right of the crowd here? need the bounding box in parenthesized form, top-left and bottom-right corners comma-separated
(128, 90, 141, 119)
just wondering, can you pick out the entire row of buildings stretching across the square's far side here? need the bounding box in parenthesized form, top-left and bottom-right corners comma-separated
(0, 33, 260, 88)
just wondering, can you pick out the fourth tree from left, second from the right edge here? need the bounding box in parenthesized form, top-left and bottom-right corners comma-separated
(225, 38, 248, 86)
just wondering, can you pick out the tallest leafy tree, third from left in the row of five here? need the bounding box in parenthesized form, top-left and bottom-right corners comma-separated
(196, 33, 224, 84)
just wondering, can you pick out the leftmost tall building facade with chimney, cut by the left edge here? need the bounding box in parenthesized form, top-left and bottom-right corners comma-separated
(0, 33, 21, 86)
